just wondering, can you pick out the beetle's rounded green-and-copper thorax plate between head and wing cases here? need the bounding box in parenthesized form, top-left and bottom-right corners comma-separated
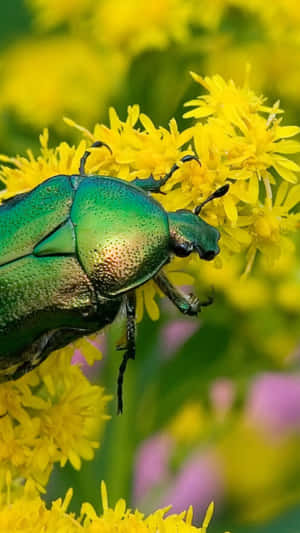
(71, 177, 169, 296)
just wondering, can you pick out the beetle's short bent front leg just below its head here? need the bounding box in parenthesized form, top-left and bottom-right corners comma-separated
(154, 271, 213, 316)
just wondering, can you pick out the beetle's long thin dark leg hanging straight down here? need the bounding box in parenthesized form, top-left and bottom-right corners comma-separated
(117, 292, 136, 414)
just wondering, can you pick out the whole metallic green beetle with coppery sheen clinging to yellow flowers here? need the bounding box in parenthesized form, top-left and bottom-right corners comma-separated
(0, 141, 229, 412)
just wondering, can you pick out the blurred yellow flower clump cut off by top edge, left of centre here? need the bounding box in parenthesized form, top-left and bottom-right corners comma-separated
(28, 0, 193, 55)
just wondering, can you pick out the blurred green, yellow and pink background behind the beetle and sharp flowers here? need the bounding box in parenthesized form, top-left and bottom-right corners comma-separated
(0, 0, 300, 533)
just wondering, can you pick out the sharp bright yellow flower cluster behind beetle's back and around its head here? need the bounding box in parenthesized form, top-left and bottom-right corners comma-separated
(1, 74, 300, 319)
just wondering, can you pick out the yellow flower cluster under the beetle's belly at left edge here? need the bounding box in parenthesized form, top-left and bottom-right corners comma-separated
(0, 339, 110, 494)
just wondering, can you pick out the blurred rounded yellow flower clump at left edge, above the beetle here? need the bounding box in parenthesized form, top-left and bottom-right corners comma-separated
(1, 36, 125, 128)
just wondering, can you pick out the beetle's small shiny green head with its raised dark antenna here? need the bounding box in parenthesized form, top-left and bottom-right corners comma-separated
(168, 185, 229, 261)
